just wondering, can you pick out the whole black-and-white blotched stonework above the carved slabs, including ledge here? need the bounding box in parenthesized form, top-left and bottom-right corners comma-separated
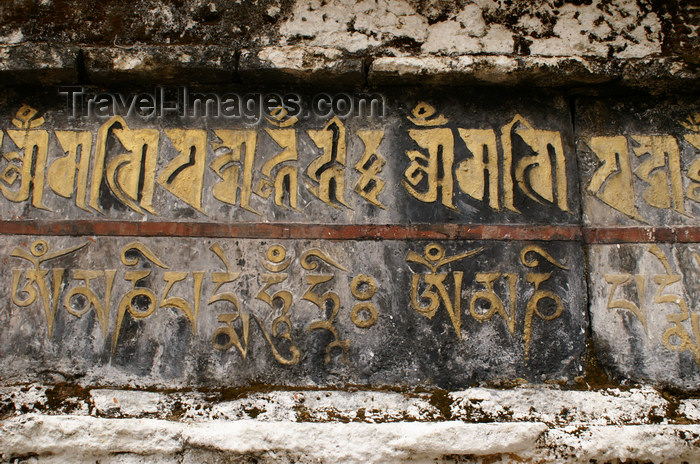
(0, 0, 700, 91)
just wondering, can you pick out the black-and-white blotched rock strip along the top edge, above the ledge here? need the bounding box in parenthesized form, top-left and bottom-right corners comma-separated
(0, 0, 680, 58)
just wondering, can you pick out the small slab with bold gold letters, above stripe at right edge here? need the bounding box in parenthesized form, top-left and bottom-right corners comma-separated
(576, 98, 700, 226)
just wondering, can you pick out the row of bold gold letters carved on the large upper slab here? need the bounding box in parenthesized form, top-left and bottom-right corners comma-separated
(0, 102, 576, 222)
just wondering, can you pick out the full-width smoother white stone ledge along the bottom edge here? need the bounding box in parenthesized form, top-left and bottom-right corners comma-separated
(0, 414, 700, 464)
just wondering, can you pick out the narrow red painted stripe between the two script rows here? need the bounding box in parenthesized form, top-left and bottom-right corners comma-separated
(0, 220, 700, 244)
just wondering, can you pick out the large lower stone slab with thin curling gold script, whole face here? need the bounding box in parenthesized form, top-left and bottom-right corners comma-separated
(0, 236, 587, 388)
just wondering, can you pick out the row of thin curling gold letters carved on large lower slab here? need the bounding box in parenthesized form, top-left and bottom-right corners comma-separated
(0, 237, 585, 386)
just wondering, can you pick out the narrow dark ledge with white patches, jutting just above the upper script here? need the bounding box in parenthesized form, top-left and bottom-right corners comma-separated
(0, 42, 700, 92)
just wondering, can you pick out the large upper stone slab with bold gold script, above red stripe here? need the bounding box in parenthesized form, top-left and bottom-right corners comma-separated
(0, 88, 579, 224)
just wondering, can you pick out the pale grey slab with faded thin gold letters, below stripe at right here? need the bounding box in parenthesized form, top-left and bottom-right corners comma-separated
(589, 243, 700, 390)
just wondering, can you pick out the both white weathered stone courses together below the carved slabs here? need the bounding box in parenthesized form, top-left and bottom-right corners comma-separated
(0, 384, 700, 463)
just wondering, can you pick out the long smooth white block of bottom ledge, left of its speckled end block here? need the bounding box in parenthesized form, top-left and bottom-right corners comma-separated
(0, 415, 547, 463)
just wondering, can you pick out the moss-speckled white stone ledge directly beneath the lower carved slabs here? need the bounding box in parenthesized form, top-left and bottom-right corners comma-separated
(0, 384, 700, 426)
